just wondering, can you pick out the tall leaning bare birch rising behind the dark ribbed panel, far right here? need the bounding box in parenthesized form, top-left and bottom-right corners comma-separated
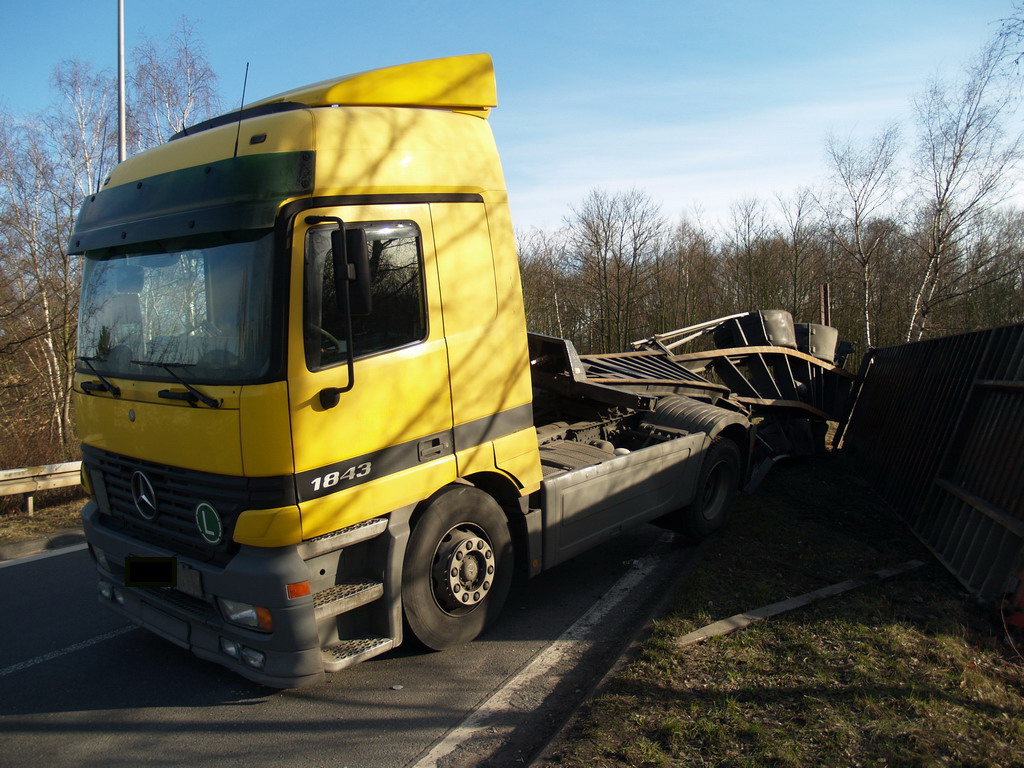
(905, 41, 1022, 341)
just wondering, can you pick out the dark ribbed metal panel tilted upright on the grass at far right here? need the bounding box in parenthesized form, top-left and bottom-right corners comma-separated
(843, 325, 1024, 600)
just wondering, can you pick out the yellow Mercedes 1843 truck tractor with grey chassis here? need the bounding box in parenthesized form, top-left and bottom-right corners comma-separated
(72, 54, 750, 687)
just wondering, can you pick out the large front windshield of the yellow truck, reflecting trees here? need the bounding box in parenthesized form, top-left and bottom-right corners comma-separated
(78, 233, 273, 384)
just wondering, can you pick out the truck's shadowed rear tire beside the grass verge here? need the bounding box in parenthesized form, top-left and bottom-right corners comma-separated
(654, 437, 740, 541)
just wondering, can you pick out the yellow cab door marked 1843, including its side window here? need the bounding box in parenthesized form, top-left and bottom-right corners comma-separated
(288, 205, 456, 539)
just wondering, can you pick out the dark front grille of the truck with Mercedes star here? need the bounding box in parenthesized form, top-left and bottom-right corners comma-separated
(82, 445, 295, 564)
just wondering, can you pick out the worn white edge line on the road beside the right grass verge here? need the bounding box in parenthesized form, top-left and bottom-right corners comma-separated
(410, 555, 664, 768)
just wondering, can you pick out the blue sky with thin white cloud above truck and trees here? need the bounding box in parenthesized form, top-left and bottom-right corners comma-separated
(0, 0, 1013, 228)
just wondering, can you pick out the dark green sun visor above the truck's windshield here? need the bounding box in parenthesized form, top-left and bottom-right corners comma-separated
(70, 152, 314, 253)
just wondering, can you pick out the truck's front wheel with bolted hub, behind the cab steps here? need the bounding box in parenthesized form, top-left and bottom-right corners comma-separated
(401, 485, 513, 650)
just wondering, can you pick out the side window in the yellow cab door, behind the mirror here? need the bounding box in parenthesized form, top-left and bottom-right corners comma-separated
(303, 221, 427, 371)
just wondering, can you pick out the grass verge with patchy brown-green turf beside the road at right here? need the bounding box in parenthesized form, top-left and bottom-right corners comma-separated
(539, 457, 1024, 768)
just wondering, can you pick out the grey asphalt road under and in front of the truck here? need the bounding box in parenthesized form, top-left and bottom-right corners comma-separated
(0, 526, 692, 768)
